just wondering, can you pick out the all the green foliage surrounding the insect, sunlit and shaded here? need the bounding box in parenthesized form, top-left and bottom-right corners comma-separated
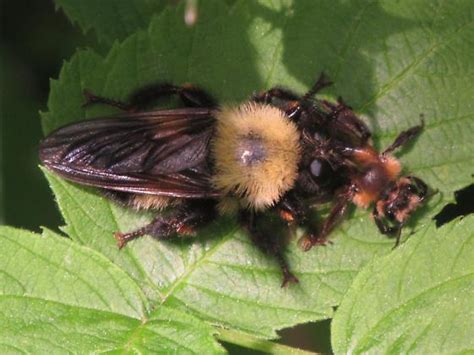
(0, 0, 474, 353)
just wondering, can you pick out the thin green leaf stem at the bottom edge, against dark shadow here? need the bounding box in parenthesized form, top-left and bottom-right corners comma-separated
(216, 328, 317, 355)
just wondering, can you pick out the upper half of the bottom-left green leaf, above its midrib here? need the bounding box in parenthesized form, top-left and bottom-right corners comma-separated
(0, 227, 146, 318)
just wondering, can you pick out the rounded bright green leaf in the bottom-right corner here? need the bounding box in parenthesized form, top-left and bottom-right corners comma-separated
(332, 217, 474, 354)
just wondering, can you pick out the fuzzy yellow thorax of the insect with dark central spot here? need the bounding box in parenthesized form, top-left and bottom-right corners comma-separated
(211, 103, 301, 210)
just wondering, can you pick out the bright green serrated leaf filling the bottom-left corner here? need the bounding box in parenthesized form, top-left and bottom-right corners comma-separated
(0, 227, 223, 353)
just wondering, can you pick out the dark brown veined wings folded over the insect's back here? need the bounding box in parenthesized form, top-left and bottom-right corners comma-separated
(40, 108, 219, 198)
